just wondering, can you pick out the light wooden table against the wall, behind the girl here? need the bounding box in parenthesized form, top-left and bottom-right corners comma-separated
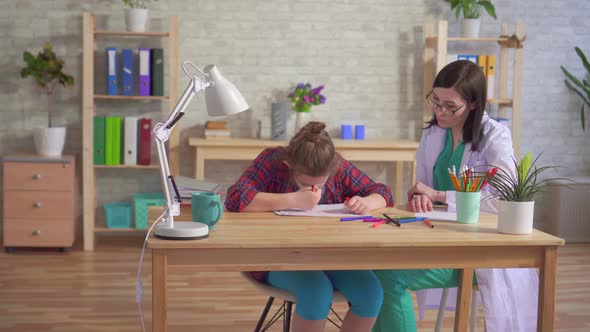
(188, 137, 418, 204)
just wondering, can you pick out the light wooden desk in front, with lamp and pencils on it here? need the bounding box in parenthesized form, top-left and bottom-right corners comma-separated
(148, 207, 564, 332)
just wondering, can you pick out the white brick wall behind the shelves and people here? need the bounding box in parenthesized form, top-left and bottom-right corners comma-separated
(0, 0, 590, 228)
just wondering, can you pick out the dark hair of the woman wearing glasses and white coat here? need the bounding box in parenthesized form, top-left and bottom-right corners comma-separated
(426, 60, 487, 151)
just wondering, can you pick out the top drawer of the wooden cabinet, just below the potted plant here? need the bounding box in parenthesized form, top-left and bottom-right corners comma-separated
(4, 162, 75, 191)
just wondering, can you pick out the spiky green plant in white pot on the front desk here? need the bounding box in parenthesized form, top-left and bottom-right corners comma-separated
(487, 152, 555, 234)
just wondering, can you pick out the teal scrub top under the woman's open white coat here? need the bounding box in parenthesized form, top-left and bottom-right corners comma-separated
(433, 128, 465, 191)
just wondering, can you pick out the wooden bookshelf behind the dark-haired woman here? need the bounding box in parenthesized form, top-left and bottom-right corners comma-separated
(423, 21, 524, 158)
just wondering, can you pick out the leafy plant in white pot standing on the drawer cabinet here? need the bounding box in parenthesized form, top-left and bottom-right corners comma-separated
(20, 43, 74, 157)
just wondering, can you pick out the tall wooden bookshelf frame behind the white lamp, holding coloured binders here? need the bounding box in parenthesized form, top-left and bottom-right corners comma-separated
(82, 12, 180, 251)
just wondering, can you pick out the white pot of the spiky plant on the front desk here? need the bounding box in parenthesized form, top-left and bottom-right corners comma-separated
(498, 201, 535, 234)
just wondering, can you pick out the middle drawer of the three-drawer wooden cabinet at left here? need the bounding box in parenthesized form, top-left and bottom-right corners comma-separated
(4, 191, 74, 219)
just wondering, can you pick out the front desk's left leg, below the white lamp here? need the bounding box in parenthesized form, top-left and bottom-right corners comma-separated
(152, 250, 168, 332)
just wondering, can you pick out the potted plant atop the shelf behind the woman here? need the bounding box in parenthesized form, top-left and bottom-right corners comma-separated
(444, 0, 497, 38)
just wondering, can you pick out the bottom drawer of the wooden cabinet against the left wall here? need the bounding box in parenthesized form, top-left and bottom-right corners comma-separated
(4, 219, 74, 247)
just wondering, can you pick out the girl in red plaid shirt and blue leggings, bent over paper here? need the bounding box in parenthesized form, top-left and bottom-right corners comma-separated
(225, 122, 393, 332)
